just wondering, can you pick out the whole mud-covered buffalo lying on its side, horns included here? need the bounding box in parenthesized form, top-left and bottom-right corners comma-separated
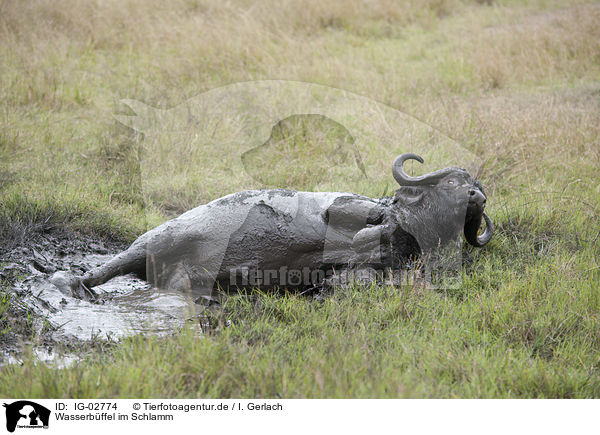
(51, 154, 494, 297)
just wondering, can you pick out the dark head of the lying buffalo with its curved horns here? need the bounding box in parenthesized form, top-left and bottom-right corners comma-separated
(392, 153, 494, 247)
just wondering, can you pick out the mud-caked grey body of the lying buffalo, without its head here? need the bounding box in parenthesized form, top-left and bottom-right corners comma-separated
(70, 189, 418, 293)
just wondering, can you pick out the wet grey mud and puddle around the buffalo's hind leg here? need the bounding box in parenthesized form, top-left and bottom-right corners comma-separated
(0, 232, 194, 363)
